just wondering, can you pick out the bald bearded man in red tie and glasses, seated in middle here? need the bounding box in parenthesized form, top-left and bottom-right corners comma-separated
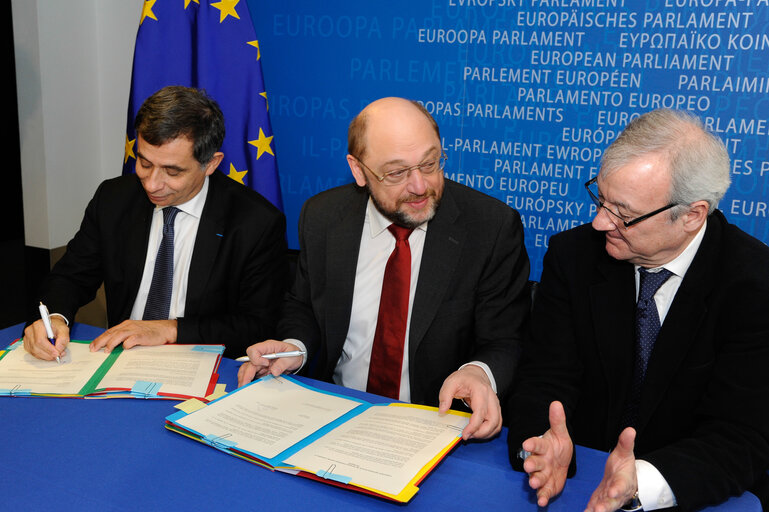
(239, 98, 529, 439)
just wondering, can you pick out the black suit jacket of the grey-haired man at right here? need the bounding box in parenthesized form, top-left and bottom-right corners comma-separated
(507, 211, 769, 510)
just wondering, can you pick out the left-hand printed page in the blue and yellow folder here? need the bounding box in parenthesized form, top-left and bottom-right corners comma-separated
(176, 378, 360, 459)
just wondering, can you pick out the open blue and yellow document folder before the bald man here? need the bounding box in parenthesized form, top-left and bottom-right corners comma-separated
(166, 376, 470, 502)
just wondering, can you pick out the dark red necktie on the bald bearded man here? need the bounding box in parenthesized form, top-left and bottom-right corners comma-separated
(366, 224, 414, 400)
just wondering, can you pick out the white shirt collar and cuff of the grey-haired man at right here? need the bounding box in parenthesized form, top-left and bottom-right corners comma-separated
(635, 221, 707, 510)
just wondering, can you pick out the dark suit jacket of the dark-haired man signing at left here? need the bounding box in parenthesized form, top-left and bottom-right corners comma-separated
(36, 171, 286, 357)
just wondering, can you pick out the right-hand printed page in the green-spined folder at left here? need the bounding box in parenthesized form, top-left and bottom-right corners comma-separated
(96, 345, 218, 396)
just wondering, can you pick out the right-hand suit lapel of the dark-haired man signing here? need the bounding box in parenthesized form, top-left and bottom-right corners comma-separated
(184, 171, 224, 316)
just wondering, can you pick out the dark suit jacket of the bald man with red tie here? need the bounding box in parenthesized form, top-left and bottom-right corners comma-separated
(278, 180, 529, 405)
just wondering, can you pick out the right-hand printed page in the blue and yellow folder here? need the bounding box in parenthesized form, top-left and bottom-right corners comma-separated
(287, 406, 468, 495)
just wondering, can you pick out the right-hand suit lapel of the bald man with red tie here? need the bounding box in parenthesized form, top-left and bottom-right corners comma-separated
(409, 182, 467, 361)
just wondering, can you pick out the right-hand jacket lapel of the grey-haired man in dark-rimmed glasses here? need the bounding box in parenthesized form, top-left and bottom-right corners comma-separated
(638, 215, 722, 432)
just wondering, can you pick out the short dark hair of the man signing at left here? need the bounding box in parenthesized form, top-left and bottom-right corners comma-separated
(134, 85, 224, 166)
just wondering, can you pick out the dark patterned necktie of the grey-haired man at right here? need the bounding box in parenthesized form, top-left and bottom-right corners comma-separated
(623, 268, 673, 427)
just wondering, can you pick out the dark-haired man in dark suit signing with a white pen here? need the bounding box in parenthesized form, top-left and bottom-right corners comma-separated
(24, 86, 286, 360)
